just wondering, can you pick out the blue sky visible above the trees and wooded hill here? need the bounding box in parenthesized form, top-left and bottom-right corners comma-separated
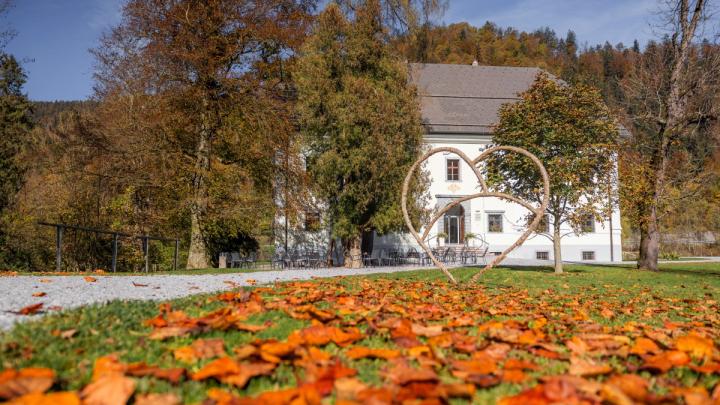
(9, 0, 657, 100)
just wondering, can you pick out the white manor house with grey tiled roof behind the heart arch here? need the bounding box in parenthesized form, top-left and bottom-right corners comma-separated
(366, 63, 622, 262)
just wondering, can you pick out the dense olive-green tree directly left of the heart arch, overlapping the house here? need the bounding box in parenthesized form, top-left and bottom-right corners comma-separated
(295, 1, 424, 267)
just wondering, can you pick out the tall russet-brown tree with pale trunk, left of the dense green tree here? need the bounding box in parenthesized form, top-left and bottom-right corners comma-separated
(94, 0, 314, 268)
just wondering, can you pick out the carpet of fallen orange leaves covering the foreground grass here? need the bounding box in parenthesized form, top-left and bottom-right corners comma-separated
(0, 278, 720, 405)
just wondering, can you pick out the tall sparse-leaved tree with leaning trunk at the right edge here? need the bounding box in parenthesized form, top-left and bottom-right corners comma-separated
(621, 0, 720, 271)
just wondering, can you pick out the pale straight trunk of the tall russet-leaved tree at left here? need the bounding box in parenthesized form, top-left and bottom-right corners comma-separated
(187, 109, 210, 269)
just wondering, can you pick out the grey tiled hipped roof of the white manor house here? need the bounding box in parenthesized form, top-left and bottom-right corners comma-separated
(410, 63, 541, 134)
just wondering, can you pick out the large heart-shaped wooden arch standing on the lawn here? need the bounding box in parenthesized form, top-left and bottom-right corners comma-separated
(401, 146, 550, 284)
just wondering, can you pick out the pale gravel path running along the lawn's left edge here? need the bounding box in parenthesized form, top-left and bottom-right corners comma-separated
(0, 266, 456, 331)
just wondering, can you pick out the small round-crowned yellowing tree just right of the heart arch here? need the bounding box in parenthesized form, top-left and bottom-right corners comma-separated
(488, 74, 618, 273)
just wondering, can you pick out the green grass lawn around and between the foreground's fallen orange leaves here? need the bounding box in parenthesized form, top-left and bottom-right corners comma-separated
(0, 263, 720, 403)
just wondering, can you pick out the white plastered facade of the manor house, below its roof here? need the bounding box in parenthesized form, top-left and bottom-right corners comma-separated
(373, 134, 622, 262)
